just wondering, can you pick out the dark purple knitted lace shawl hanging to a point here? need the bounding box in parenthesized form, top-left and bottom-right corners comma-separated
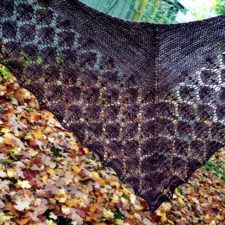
(0, 0, 225, 211)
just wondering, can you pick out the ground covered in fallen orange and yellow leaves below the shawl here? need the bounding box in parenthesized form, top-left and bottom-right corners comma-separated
(0, 66, 225, 225)
